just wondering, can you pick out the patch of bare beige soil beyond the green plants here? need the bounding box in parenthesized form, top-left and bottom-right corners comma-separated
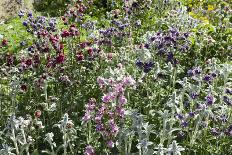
(0, 0, 33, 21)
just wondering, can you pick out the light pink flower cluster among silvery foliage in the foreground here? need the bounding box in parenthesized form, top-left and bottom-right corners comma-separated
(82, 67, 135, 148)
